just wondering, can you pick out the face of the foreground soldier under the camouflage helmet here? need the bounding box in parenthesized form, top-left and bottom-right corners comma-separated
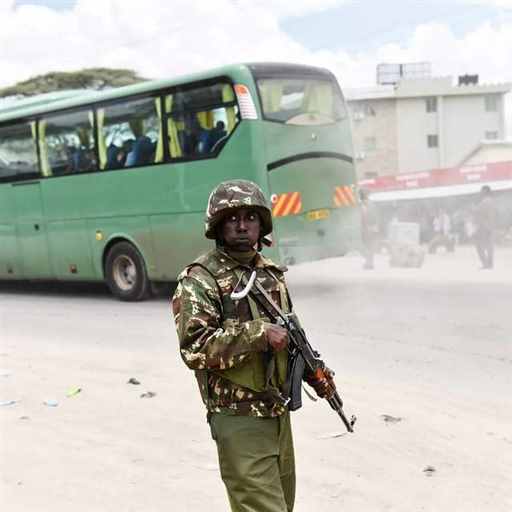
(221, 208, 261, 251)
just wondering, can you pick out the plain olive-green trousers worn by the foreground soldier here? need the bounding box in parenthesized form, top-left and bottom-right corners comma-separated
(210, 412, 295, 512)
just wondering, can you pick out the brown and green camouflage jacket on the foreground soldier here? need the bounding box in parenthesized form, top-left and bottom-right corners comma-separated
(172, 249, 290, 417)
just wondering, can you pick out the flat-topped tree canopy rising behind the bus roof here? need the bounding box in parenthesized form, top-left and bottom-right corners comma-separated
(0, 68, 147, 98)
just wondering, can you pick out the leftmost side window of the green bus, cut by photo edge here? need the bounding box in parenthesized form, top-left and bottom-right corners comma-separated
(0, 122, 39, 182)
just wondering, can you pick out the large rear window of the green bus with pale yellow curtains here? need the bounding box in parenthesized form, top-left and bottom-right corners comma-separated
(257, 76, 346, 126)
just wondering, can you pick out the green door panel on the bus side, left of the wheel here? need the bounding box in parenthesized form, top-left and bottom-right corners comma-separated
(12, 180, 50, 278)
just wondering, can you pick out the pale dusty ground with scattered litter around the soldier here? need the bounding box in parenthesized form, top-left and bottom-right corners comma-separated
(0, 249, 512, 512)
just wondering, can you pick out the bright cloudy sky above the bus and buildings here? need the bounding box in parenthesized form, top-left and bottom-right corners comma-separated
(0, 0, 512, 135)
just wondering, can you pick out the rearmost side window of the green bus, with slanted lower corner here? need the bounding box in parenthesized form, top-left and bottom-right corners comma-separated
(165, 83, 239, 159)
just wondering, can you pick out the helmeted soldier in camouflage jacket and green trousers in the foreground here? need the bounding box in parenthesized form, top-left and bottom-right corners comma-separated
(172, 180, 335, 512)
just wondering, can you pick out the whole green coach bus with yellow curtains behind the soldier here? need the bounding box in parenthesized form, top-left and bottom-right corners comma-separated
(0, 63, 360, 300)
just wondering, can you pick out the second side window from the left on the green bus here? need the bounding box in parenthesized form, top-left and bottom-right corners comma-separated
(39, 111, 97, 176)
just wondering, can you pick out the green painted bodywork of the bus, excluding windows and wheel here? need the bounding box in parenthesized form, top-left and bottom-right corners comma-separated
(0, 64, 360, 299)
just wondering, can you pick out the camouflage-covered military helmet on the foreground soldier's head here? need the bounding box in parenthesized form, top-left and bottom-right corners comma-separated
(204, 180, 272, 240)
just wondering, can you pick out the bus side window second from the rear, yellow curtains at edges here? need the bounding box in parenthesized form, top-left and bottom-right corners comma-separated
(98, 98, 159, 169)
